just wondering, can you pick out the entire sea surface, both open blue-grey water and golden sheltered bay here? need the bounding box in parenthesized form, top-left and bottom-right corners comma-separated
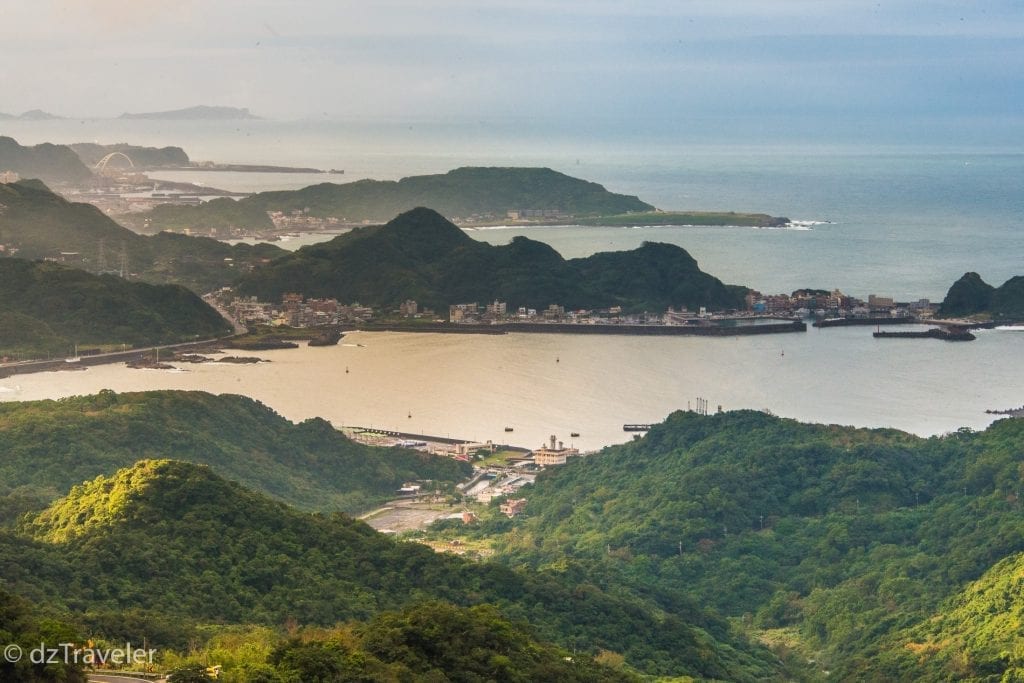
(0, 121, 1024, 440)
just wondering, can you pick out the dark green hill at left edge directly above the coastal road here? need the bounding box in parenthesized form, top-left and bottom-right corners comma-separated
(0, 258, 231, 357)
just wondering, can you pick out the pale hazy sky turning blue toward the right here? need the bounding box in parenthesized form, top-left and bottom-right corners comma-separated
(0, 0, 1024, 141)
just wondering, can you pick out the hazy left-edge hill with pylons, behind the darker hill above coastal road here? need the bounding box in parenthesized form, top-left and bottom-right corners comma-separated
(0, 180, 285, 293)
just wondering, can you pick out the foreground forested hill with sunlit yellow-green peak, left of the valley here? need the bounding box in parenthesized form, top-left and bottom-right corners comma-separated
(0, 460, 779, 681)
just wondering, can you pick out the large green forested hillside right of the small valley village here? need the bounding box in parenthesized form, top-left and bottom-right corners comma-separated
(454, 412, 1024, 680)
